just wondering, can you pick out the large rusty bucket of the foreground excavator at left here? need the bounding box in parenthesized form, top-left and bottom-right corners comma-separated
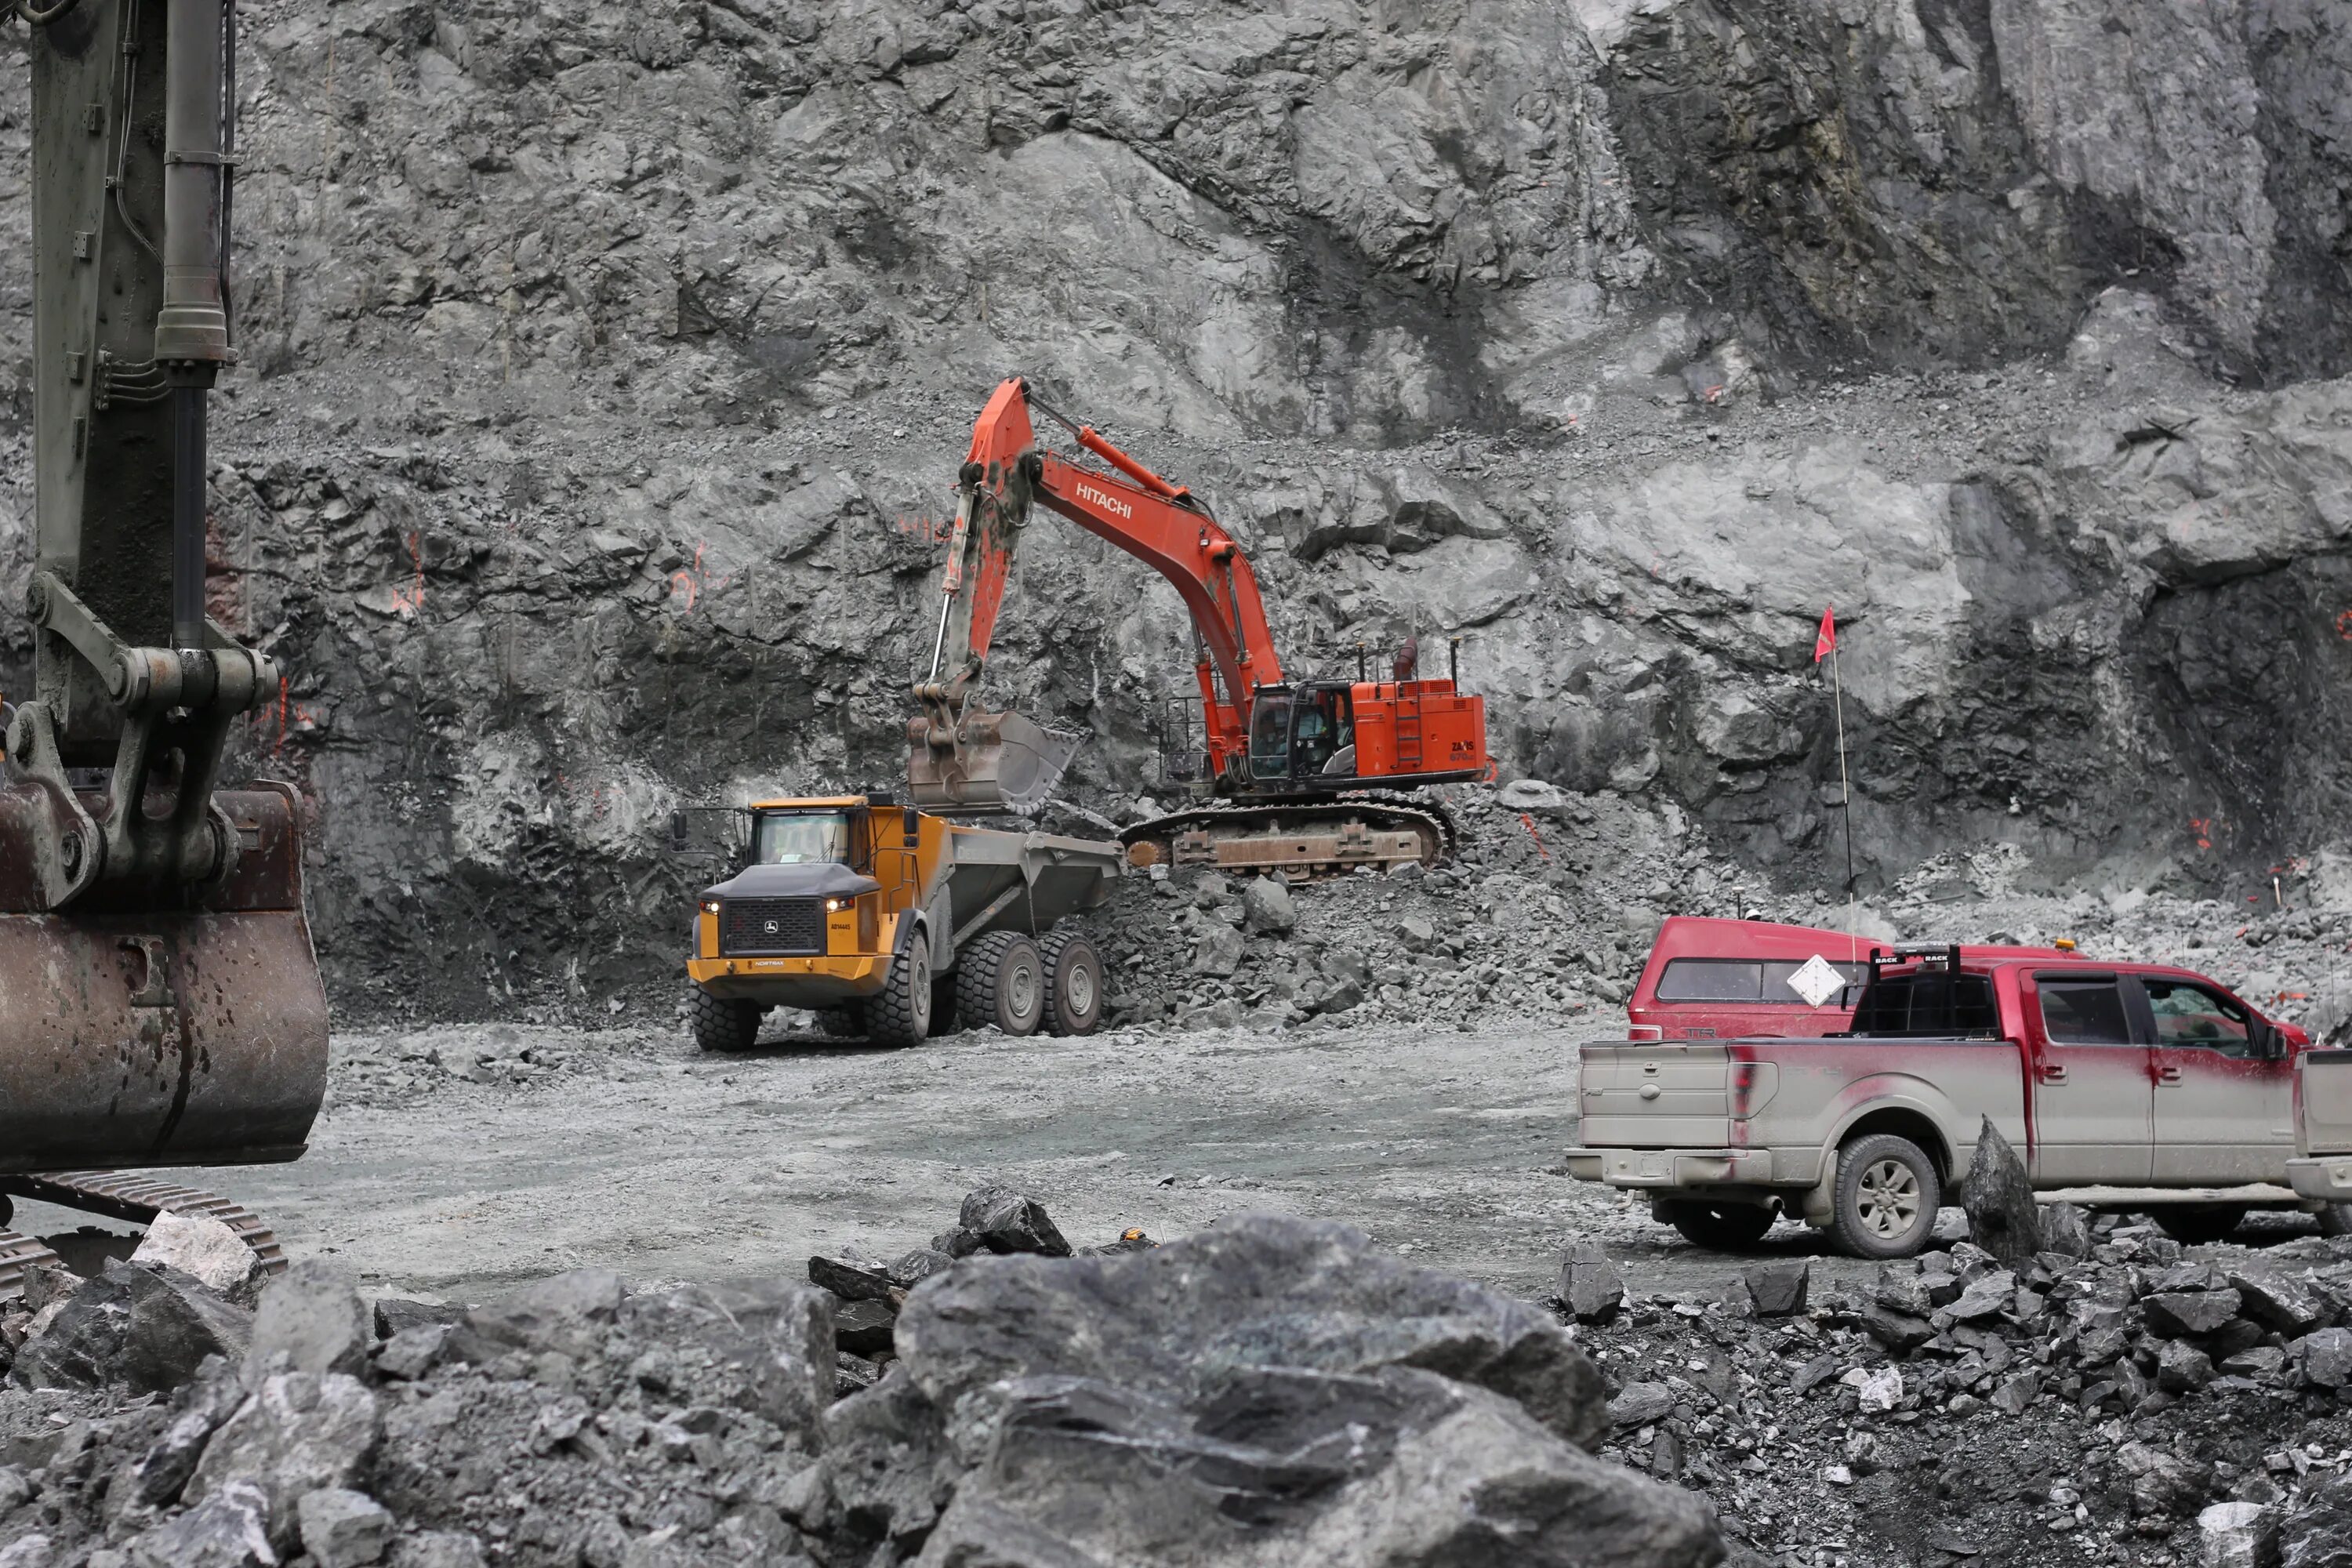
(0, 785, 327, 1178)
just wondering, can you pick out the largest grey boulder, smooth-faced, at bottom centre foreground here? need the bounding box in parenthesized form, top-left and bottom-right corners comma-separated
(875, 1215, 1722, 1568)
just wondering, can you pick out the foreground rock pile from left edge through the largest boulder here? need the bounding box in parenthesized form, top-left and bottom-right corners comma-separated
(0, 1189, 1722, 1568)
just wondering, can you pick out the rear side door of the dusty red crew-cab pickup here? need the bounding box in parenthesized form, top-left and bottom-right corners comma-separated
(2023, 971, 2154, 1185)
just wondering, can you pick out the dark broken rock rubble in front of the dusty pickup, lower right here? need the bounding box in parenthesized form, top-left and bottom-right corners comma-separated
(1555, 1210, 2352, 1566)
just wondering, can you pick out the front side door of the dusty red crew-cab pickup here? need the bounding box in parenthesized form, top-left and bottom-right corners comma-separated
(2124, 975, 2296, 1185)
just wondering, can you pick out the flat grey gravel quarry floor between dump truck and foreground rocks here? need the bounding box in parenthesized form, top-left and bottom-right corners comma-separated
(19, 1025, 1818, 1300)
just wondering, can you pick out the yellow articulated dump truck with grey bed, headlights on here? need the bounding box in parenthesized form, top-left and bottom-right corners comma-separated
(670, 794, 1127, 1051)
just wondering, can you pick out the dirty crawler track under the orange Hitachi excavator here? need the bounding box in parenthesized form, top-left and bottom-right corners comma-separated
(1120, 789, 1456, 879)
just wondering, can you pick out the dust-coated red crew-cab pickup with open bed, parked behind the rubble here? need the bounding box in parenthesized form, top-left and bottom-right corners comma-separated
(1566, 947, 2352, 1258)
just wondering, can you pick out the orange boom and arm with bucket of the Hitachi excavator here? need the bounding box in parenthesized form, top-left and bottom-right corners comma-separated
(910, 379, 1282, 808)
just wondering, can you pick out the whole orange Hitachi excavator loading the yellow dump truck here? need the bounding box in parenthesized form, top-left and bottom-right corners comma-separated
(908, 379, 1491, 877)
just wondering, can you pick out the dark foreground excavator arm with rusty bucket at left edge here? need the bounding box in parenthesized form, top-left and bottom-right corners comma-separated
(0, 0, 327, 1222)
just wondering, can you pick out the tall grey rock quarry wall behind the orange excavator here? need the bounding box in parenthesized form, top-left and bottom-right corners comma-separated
(0, 0, 2352, 1011)
